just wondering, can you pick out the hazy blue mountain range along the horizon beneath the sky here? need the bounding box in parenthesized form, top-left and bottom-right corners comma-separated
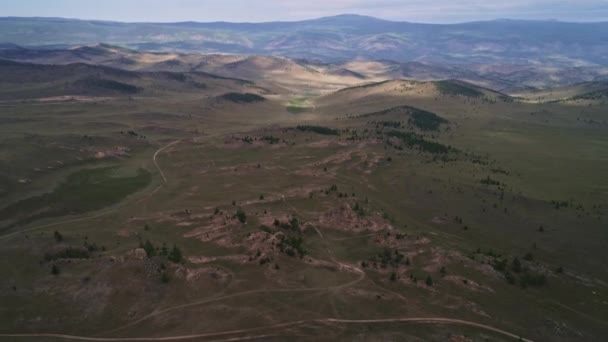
(0, 15, 608, 67)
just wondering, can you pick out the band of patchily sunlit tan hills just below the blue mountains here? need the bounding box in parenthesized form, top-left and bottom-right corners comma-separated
(0, 44, 608, 93)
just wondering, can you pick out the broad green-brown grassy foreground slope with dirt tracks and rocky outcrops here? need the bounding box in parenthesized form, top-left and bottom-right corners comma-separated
(0, 57, 608, 341)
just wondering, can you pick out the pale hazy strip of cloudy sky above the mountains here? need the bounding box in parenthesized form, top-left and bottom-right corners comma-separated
(0, 0, 608, 23)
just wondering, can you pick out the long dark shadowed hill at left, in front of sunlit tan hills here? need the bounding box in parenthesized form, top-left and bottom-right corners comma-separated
(0, 60, 262, 100)
